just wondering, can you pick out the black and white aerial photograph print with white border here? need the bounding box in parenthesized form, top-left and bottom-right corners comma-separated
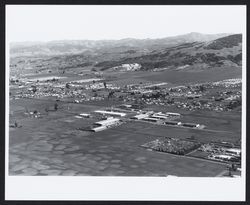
(6, 5, 246, 200)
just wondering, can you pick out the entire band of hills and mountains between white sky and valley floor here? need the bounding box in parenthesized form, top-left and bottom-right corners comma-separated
(10, 32, 242, 71)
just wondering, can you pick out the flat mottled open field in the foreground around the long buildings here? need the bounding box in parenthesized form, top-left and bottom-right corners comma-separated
(9, 99, 236, 177)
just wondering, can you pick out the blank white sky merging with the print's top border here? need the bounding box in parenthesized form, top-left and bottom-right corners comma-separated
(6, 5, 246, 42)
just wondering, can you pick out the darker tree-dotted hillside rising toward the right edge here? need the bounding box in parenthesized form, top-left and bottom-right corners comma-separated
(96, 34, 242, 70)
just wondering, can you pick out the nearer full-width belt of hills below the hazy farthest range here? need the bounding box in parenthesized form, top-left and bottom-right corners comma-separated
(10, 34, 242, 72)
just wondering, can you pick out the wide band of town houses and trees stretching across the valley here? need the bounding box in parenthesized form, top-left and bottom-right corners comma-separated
(10, 69, 241, 114)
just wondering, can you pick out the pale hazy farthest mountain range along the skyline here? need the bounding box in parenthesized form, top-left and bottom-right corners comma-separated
(10, 32, 230, 56)
